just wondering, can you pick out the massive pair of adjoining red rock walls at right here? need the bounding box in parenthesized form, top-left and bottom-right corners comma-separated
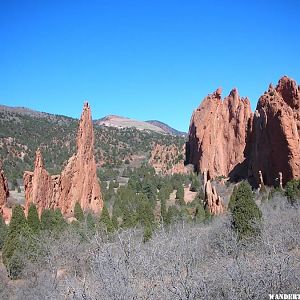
(186, 76, 300, 187)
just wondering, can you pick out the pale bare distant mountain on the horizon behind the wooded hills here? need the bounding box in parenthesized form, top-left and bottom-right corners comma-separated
(95, 115, 186, 136)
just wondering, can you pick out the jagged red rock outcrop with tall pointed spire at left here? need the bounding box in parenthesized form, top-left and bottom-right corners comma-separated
(24, 103, 103, 217)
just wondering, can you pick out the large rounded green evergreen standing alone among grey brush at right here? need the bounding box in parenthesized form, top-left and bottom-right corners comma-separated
(231, 181, 262, 239)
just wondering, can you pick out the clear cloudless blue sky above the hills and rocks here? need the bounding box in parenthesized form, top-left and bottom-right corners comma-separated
(0, 0, 300, 131)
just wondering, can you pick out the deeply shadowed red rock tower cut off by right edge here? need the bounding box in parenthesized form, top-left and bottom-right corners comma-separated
(250, 76, 300, 185)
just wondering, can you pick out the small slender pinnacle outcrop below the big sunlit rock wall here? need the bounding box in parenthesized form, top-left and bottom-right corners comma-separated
(203, 170, 225, 215)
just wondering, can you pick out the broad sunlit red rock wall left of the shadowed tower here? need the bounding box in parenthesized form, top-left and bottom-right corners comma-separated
(186, 88, 252, 178)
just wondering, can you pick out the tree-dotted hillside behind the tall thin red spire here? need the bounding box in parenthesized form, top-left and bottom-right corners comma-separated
(0, 106, 184, 180)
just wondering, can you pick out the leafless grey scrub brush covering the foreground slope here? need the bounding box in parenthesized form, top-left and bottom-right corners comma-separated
(0, 196, 300, 300)
